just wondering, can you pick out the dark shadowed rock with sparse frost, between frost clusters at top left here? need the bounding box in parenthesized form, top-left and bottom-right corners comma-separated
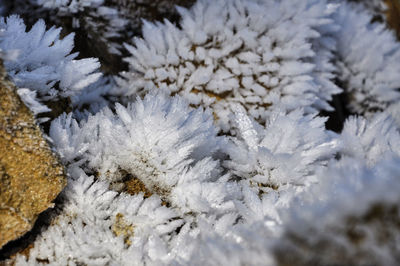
(73, 0, 195, 74)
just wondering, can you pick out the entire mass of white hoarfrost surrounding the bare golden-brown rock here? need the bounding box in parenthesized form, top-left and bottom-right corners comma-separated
(0, 0, 400, 265)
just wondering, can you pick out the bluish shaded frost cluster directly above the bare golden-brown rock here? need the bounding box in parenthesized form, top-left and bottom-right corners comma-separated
(0, 16, 101, 113)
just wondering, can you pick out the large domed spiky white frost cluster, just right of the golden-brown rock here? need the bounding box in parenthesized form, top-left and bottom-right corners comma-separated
(50, 94, 235, 215)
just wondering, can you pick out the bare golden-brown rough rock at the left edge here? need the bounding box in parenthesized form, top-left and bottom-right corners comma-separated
(0, 63, 66, 248)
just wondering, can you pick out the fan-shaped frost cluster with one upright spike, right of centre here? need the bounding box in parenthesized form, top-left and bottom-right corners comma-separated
(224, 108, 338, 222)
